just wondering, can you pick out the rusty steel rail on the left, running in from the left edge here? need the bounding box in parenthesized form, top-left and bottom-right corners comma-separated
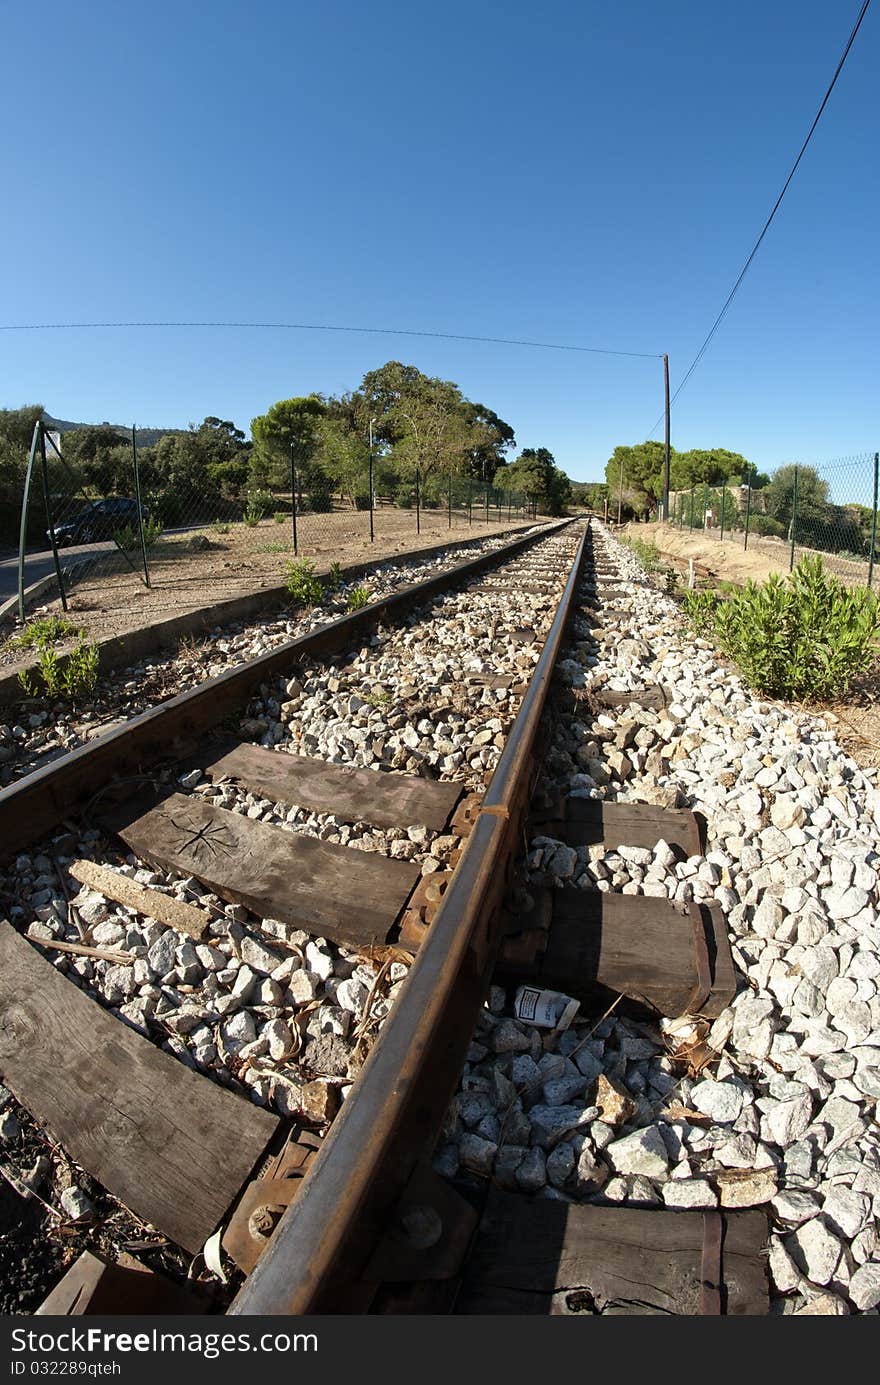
(0, 519, 572, 860)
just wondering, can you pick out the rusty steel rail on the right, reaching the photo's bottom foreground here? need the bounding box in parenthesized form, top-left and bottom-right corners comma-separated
(229, 520, 588, 1316)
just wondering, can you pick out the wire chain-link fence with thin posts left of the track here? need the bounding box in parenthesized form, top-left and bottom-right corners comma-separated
(10, 420, 536, 618)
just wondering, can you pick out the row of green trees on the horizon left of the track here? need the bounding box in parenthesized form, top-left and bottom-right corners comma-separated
(0, 361, 571, 530)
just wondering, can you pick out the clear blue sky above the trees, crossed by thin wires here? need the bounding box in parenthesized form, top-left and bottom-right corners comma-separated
(0, 0, 880, 479)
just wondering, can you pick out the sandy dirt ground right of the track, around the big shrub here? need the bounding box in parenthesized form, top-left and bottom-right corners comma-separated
(621, 524, 880, 770)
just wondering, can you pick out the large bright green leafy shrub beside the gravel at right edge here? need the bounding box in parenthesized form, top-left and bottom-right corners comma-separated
(684, 557, 880, 701)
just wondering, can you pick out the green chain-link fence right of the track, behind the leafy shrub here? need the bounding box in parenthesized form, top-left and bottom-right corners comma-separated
(669, 452, 880, 586)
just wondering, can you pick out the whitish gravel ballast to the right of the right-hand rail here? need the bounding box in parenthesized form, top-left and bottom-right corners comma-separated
(437, 525, 880, 1316)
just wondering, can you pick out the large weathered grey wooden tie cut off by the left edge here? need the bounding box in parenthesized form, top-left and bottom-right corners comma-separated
(0, 922, 279, 1253)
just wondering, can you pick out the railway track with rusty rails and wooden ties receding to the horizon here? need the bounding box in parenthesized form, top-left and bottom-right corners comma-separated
(0, 526, 766, 1314)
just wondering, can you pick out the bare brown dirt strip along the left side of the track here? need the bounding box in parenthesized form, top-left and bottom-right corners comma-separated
(4, 508, 535, 653)
